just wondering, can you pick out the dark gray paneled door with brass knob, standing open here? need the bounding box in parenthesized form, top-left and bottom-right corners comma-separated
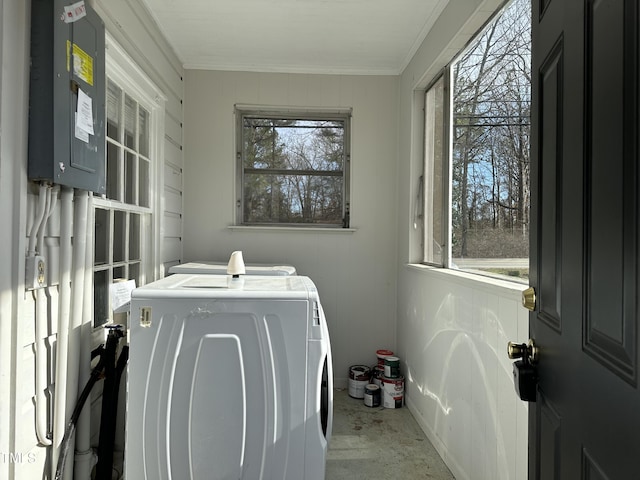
(529, 0, 640, 480)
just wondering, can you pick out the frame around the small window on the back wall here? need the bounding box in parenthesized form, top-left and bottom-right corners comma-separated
(234, 104, 352, 229)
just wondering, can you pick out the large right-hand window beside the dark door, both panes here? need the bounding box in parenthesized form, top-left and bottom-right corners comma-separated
(423, 0, 531, 282)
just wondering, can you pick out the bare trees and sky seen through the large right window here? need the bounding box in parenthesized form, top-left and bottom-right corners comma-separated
(451, 0, 531, 278)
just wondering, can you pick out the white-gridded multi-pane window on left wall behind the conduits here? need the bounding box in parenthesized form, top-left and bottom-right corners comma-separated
(94, 78, 153, 327)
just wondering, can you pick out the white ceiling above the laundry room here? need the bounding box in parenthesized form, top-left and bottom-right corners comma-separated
(143, 0, 449, 75)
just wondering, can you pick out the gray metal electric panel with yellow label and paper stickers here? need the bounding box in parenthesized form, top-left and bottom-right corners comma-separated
(28, 0, 106, 194)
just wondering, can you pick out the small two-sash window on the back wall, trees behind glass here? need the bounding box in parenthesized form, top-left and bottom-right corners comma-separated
(237, 110, 350, 227)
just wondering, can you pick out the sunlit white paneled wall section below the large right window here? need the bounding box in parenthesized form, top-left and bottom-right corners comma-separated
(398, 267, 529, 480)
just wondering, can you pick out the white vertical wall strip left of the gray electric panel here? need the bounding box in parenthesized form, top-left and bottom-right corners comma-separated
(0, 0, 34, 479)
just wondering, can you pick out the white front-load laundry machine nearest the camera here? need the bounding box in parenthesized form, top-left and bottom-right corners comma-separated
(125, 274, 333, 480)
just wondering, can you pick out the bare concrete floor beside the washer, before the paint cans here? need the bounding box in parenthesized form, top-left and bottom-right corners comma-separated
(325, 389, 454, 480)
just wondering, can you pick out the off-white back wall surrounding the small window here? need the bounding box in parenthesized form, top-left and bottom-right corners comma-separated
(184, 70, 398, 385)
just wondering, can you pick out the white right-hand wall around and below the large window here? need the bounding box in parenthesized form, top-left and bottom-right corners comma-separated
(397, 0, 528, 480)
